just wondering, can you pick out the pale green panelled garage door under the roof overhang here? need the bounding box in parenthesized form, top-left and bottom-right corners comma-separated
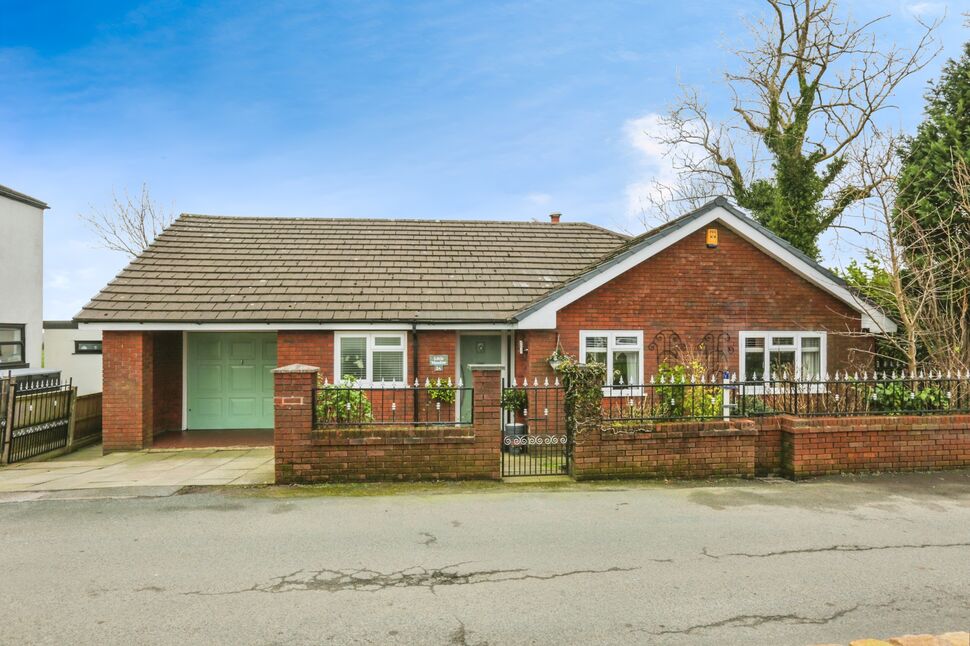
(186, 332, 276, 430)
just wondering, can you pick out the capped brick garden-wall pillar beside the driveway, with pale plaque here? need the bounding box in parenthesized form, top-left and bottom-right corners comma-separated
(273, 363, 320, 484)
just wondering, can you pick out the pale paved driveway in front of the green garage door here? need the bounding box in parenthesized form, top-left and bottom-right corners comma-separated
(0, 445, 274, 493)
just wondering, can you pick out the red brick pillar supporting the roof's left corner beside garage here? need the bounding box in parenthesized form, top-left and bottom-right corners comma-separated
(102, 330, 154, 453)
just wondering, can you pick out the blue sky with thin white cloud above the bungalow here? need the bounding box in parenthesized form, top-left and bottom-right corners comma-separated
(0, 0, 970, 319)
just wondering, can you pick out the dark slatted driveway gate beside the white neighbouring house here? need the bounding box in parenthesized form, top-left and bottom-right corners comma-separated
(0, 380, 73, 463)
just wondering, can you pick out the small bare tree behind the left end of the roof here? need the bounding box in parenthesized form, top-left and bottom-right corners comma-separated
(79, 184, 175, 258)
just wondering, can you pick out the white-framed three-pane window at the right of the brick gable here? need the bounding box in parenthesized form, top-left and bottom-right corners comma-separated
(740, 332, 826, 381)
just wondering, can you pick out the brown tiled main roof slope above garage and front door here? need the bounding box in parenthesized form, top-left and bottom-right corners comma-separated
(77, 215, 627, 323)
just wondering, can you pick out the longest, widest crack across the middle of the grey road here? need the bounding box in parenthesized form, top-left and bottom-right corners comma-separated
(183, 563, 640, 596)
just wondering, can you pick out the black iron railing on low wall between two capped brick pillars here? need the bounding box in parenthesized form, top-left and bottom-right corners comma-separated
(313, 379, 475, 429)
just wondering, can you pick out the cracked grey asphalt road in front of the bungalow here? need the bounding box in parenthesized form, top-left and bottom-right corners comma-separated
(0, 472, 970, 645)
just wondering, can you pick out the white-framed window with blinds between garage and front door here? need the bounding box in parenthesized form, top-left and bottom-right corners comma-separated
(335, 332, 405, 384)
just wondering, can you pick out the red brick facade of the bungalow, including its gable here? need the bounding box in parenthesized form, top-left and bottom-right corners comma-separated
(104, 224, 871, 464)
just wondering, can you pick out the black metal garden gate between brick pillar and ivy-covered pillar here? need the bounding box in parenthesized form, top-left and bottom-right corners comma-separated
(502, 381, 572, 478)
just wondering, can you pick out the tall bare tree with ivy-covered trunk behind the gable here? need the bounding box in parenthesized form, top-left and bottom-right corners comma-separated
(636, 0, 939, 256)
